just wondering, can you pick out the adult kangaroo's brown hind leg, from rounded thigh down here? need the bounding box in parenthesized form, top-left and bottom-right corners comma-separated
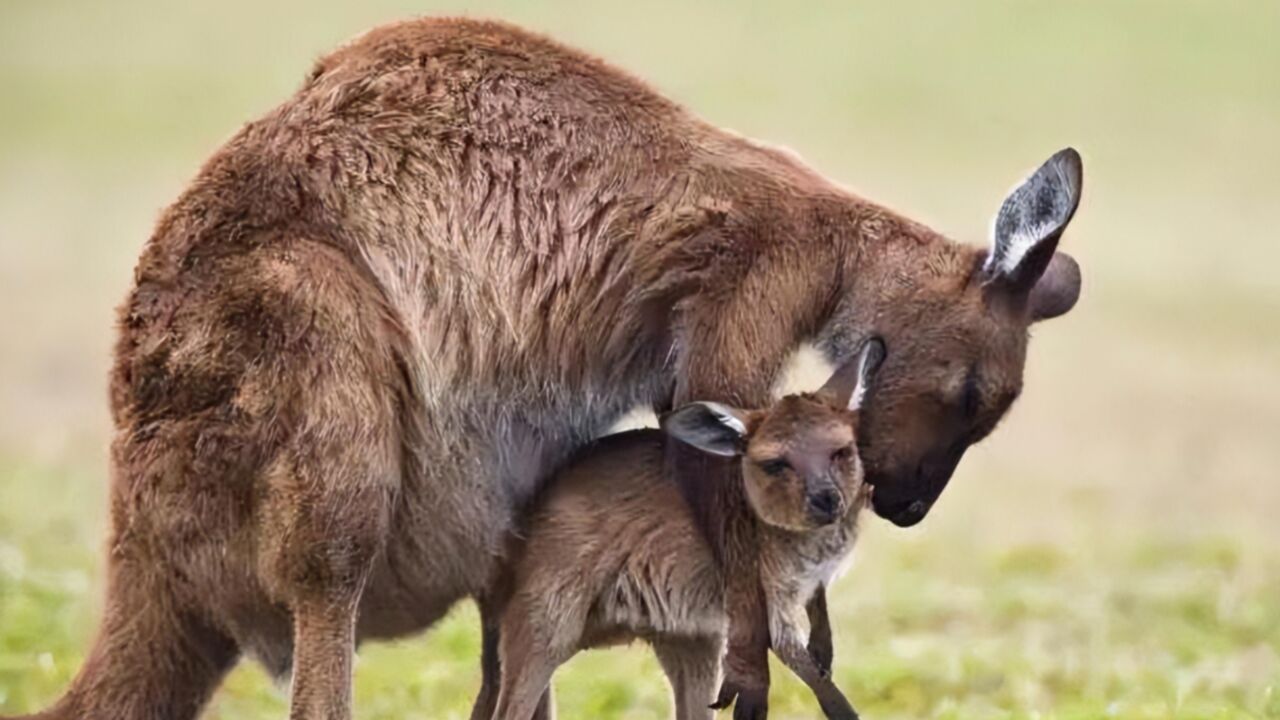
(241, 241, 408, 720)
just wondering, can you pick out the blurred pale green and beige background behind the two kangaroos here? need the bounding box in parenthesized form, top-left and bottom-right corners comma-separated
(0, 0, 1280, 719)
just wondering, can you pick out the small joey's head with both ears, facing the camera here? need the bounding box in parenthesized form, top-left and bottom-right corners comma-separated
(663, 338, 884, 532)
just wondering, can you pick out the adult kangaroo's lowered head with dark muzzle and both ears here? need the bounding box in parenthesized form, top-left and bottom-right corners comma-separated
(818, 149, 1082, 527)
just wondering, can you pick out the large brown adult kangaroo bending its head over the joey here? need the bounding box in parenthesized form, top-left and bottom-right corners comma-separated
(15, 19, 1080, 720)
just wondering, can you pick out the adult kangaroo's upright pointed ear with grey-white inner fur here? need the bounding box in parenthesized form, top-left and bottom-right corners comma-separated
(983, 147, 1084, 293)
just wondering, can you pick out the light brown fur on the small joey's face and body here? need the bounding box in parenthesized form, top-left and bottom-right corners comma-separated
(472, 379, 868, 720)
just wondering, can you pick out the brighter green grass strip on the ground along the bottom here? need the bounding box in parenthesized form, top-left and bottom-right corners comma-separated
(0, 466, 1280, 719)
